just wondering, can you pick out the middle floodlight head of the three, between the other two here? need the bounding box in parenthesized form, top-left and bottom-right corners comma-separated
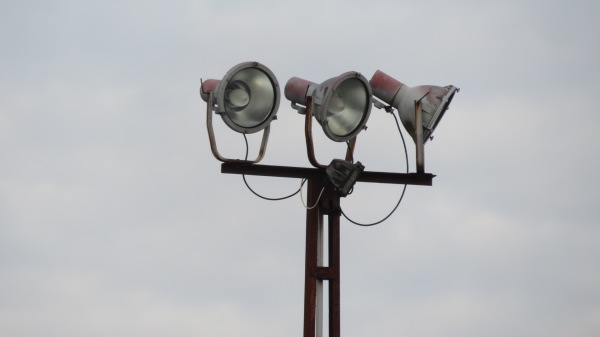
(284, 71, 372, 142)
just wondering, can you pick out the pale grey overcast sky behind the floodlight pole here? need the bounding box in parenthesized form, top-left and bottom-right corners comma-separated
(0, 0, 600, 337)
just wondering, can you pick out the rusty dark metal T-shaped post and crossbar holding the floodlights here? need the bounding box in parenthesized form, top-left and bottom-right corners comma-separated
(221, 162, 435, 337)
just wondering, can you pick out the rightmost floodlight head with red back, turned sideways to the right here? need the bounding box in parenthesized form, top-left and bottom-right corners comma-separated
(370, 70, 459, 143)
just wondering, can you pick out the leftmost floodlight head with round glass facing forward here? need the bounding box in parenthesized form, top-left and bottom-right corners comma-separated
(200, 62, 279, 133)
